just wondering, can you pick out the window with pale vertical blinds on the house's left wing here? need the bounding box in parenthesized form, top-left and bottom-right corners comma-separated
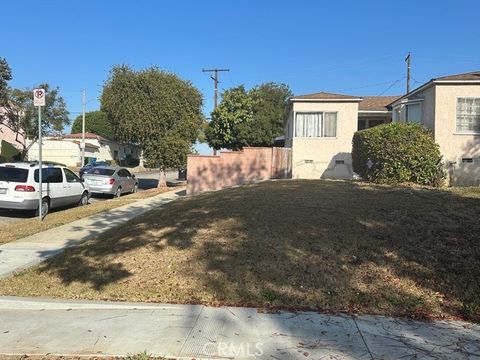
(295, 112, 337, 137)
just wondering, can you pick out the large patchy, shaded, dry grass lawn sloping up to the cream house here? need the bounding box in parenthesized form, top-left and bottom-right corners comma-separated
(0, 180, 480, 322)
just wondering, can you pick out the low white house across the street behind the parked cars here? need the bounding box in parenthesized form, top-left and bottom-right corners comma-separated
(28, 133, 140, 166)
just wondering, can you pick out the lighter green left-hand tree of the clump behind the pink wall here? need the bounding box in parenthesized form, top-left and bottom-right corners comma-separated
(205, 85, 254, 150)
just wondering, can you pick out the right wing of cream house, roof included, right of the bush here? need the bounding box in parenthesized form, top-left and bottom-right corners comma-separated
(390, 71, 480, 186)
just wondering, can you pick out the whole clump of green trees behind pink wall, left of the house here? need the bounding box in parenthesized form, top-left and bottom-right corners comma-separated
(205, 82, 292, 150)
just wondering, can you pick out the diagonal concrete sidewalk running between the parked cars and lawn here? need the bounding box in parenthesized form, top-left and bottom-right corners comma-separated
(0, 188, 185, 278)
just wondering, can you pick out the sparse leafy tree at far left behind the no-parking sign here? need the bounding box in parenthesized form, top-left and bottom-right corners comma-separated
(1, 83, 70, 157)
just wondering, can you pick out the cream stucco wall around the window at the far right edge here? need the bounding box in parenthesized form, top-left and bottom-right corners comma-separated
(435, 84, 480, 186)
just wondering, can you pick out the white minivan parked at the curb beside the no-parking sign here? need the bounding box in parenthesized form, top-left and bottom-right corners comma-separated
(0, 162, 90, 216)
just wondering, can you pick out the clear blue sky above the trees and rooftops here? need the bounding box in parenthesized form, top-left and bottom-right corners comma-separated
(0, 0, 480, 152)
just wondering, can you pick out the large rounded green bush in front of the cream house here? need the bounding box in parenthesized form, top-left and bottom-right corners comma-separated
(352, 123, 445, 186)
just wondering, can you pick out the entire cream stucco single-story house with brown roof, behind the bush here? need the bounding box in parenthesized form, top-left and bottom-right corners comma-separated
(285, 71, 480, 185)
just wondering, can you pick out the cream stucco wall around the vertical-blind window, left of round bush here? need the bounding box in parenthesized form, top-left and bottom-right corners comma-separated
(291, 102, 358, 179)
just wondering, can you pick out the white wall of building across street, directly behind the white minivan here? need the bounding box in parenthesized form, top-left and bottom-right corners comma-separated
(28, 140, 82, 166)
